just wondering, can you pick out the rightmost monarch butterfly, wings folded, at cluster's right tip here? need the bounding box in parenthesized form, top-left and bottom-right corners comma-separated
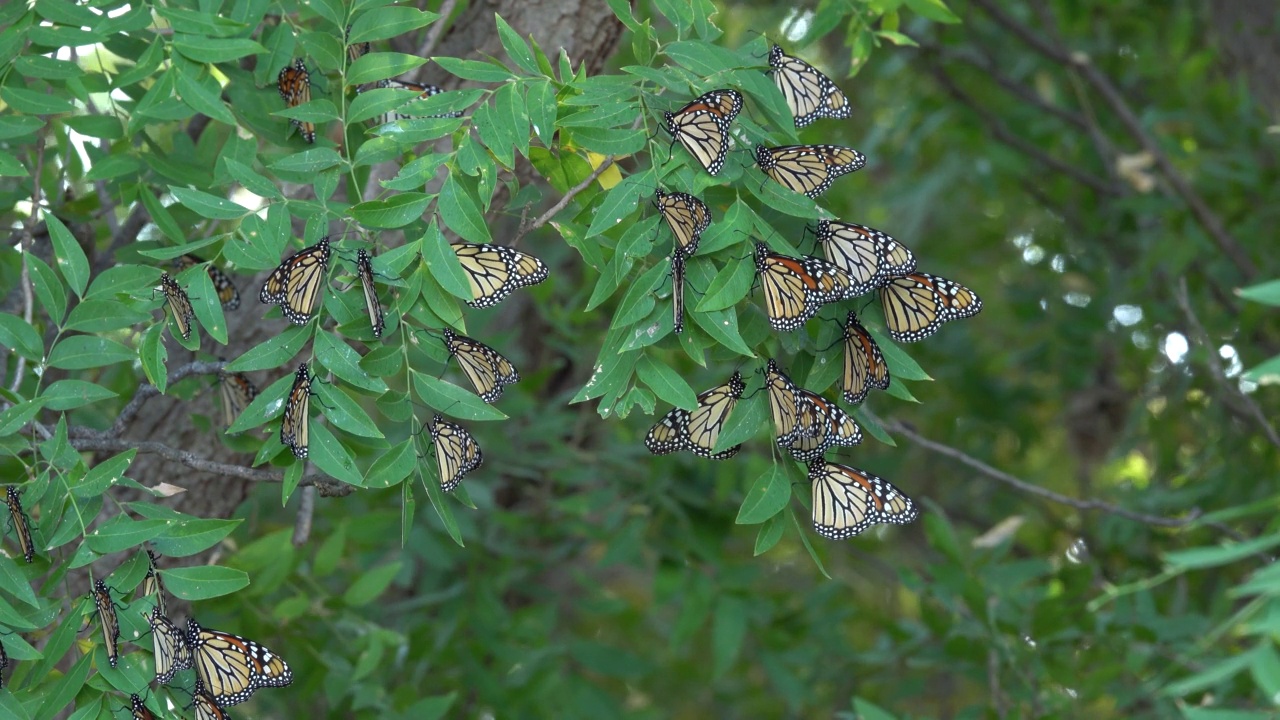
(881, 273, 982, 342)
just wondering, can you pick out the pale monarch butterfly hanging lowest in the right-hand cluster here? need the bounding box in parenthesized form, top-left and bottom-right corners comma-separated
(809, 460, 920, 539)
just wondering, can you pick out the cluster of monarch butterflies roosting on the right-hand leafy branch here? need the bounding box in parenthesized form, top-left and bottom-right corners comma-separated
(645, 45, 982, 538)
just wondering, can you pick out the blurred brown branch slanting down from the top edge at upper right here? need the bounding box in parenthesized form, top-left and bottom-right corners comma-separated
(973, 0, 1258, 279)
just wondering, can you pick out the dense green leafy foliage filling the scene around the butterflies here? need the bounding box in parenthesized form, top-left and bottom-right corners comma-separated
(0, 0, 1280, 720)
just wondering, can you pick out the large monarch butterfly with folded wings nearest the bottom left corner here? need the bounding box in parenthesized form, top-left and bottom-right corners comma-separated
(187, 618, 293, 707)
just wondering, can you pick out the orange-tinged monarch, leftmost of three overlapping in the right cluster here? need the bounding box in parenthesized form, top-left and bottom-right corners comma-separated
(755, 242, 852, 331)
